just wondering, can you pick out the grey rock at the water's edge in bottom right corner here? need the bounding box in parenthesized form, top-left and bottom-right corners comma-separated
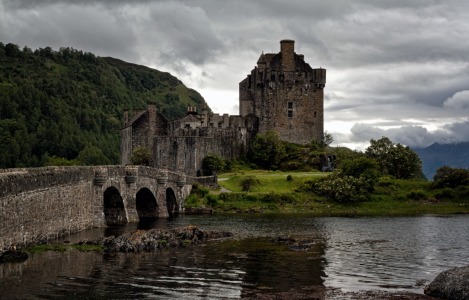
(425, 266, 469, 300)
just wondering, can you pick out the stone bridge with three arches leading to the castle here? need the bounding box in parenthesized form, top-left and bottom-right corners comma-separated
(0, 166, 217, 252)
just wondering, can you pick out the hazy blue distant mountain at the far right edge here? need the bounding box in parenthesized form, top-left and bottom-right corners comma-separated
(414, 142, 469, 180)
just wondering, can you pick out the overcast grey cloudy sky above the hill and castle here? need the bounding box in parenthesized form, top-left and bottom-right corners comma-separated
(0, 0, 469, 149)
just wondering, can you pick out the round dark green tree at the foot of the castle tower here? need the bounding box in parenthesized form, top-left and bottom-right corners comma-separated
(249, 131, 285, 169)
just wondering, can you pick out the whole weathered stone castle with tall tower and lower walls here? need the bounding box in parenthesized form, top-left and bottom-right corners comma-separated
(121, 40, 326, 176)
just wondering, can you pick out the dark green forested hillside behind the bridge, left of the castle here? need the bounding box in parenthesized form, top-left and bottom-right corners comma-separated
(0, 43, 205, 168)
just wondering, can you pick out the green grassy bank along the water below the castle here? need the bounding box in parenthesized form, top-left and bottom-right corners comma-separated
(195, 171, 469, 216)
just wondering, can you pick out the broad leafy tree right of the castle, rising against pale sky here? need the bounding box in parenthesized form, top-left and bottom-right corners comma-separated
(365, 137, 422, 179)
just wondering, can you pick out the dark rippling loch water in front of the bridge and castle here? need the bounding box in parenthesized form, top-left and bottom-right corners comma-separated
(0, 214, 469, 299)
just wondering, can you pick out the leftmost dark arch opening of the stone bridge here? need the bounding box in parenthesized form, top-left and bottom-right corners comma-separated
(103, 186, 128, 226)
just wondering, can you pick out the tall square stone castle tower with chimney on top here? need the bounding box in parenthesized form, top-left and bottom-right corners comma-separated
(239, 40, 326, 144)
